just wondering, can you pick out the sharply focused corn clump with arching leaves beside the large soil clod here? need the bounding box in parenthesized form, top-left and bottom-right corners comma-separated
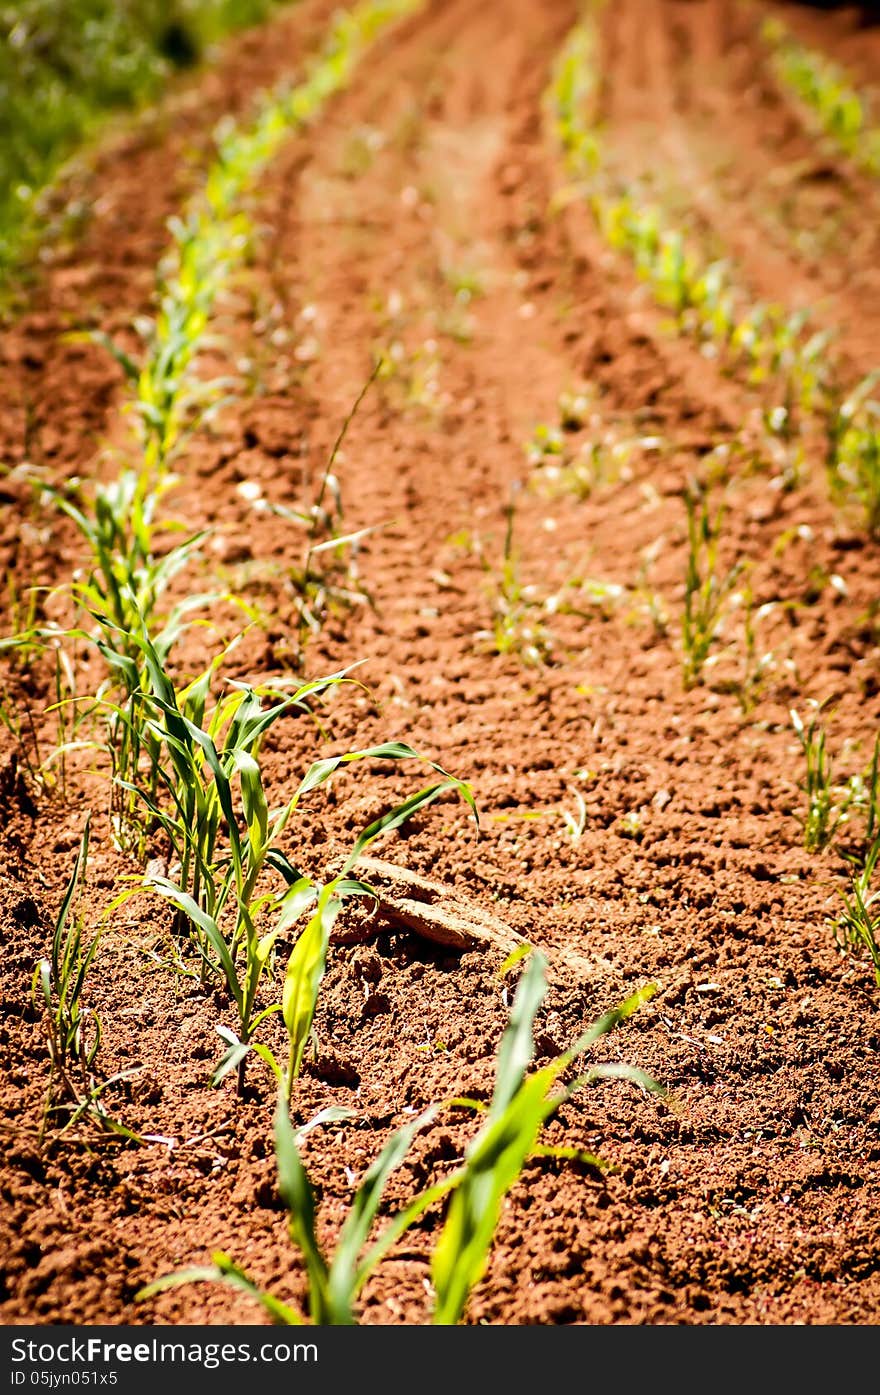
(126, 631, 476, 1092)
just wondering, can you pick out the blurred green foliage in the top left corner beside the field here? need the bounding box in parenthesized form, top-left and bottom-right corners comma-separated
(0, 0, 288, 272)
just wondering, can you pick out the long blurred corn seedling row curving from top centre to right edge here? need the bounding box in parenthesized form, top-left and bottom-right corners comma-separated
(547, 10, 880, 536)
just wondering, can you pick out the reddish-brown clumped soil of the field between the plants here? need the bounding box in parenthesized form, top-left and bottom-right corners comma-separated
(0, 0, 880, 1324)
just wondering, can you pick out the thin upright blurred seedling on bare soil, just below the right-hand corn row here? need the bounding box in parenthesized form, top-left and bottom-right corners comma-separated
(682, 490, 742, 688)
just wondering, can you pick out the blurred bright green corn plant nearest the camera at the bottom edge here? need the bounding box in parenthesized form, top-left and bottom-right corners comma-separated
(137, 954, 658, 1325)
